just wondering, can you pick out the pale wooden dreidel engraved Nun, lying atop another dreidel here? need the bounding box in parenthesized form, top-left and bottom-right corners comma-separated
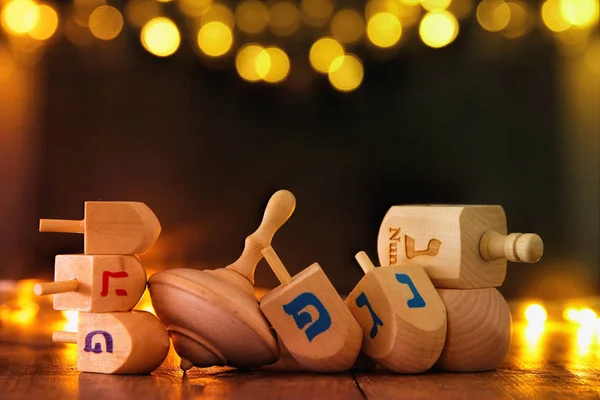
(377, 205, 544, 289)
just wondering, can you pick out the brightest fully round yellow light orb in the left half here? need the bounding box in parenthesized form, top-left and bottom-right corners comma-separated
(140, 17, 181, 57)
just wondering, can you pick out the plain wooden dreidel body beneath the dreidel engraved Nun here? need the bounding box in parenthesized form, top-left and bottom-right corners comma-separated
(436, 288, 512, 372)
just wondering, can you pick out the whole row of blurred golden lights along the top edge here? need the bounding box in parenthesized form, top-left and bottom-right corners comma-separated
(0, 0, 600, 92)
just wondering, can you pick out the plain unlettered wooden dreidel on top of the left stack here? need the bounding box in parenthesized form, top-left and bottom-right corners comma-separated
(40, 201, 161, 254)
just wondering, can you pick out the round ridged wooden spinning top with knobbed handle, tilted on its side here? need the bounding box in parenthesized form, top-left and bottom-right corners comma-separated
(148, 190, 296, 370)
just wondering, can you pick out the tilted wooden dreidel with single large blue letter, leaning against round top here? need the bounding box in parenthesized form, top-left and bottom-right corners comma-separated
(260, 246, 362, 372)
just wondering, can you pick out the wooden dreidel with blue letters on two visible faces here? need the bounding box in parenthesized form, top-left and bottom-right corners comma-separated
(346, 251, 446, 373)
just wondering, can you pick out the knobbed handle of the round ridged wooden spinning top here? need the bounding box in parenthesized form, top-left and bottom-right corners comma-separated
(227, 190, 296, 283)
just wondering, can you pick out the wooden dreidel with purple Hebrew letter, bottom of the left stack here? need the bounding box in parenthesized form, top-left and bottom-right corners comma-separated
(52, 311, 169, 374)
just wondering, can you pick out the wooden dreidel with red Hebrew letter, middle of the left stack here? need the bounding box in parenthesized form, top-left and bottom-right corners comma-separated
(33, 254, 146, 313)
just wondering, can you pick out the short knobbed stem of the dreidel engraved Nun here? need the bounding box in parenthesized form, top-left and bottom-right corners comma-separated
(479, 231, 544, 263)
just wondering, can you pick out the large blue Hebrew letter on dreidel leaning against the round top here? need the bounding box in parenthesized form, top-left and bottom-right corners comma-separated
(283, 292, 331, 342)
